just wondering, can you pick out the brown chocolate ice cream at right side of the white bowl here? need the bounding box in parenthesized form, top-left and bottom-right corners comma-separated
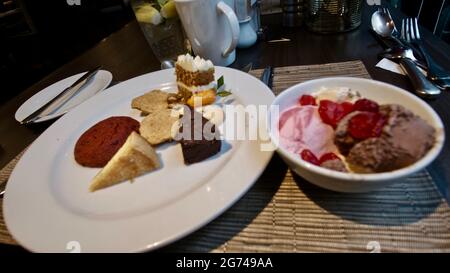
(347, 104, 435, 173)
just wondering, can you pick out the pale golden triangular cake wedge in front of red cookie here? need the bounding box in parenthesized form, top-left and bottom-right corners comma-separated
(89, 132, 161, 192)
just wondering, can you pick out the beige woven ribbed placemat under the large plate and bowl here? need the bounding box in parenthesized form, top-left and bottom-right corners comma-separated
(0, 61, 450, 252)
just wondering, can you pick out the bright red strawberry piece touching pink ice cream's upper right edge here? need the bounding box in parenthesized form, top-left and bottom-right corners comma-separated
(319, 100, 353, 128)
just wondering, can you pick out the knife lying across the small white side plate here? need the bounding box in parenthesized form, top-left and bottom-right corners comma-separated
(20, 66, 101, 124)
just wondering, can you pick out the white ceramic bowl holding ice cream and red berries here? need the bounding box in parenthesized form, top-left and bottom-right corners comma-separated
(268, 77, 445, 192)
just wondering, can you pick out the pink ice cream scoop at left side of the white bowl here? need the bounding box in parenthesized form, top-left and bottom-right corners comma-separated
(278, 105, 338, 157)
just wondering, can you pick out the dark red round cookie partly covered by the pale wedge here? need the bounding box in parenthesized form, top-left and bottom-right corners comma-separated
(74, 117, 139, 167)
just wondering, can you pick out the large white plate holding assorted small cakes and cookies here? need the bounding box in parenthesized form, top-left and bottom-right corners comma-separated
(3, 67, 274, 252)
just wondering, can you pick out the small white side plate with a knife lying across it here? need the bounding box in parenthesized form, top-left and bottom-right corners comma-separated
(15, 70, 112, 123)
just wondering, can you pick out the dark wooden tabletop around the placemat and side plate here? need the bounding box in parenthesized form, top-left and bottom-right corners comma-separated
(0, 3, 450, 251)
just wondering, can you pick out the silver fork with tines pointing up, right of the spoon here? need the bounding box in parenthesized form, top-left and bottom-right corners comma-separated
(400, 18, 450, 88)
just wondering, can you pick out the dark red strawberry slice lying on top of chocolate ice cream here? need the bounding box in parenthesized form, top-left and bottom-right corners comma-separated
(348, 112, 387, 139)
